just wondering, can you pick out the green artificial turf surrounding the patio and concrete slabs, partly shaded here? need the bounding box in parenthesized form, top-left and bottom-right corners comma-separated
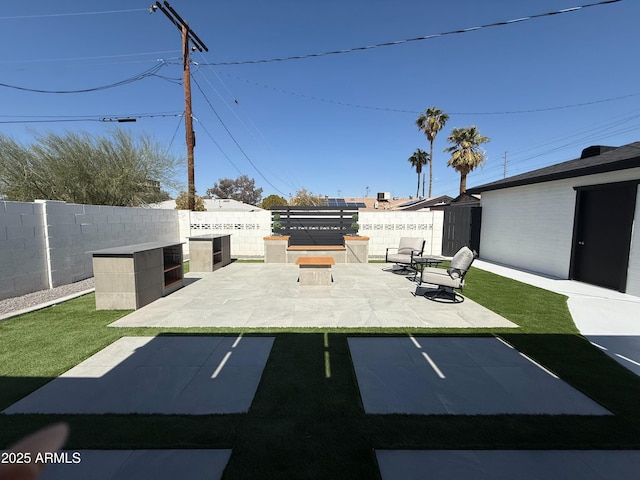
(0, 269, 640, 479)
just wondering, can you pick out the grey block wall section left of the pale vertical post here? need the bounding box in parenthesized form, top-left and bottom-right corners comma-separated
(0, 202, 49, 299)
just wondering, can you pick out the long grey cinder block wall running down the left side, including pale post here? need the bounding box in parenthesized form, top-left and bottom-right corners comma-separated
(0, 200, 180, 299)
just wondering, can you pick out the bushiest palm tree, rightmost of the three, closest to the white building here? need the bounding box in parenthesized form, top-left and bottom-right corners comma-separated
(444, 126, 491, 197)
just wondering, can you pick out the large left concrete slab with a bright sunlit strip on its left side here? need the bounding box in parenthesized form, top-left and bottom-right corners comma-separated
(5, 335, 273, 415)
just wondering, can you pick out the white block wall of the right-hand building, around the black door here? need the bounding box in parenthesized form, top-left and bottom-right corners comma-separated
(480, 168, 640, 295)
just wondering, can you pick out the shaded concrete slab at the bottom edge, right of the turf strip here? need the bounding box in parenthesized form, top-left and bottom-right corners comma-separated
(376, 450, 640, 480)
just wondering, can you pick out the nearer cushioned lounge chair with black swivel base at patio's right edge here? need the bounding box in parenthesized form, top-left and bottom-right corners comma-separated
(416, 247, 477, 303)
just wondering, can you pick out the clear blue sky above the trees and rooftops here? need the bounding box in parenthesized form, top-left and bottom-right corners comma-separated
(0, 0, 640, 201)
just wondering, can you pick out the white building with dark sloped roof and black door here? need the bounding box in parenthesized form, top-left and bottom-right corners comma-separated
(467, 142, 640, 296)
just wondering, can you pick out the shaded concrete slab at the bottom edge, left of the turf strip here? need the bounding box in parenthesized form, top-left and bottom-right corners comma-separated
(40, 450, 231, 480)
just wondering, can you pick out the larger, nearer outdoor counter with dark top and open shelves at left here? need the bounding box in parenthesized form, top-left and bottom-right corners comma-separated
(88, 242, 184, 310)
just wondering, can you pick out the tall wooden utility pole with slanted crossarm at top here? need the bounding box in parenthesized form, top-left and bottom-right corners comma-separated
(150, 0, 209, 211)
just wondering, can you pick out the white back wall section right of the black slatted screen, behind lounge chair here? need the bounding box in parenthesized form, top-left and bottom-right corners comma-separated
(358, 211, 444, 258)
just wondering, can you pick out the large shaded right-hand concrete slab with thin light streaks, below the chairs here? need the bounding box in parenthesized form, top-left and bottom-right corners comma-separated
(349, 336, 610, 415)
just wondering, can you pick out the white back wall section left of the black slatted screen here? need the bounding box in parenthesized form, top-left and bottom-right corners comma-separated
(179, 210, 271, 258)
